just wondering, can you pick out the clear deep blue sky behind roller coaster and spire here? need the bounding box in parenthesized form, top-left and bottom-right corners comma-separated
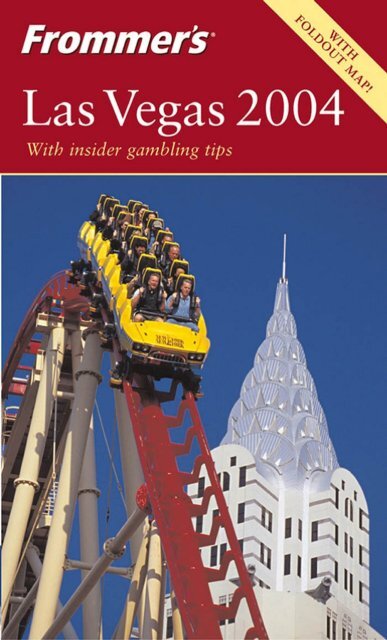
(2, 176, 387, 634)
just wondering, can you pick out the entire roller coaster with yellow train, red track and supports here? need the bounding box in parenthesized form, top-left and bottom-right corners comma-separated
(2, 195, 267, 640)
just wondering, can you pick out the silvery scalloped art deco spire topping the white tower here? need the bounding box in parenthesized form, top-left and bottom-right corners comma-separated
(222, 236, 338, 489)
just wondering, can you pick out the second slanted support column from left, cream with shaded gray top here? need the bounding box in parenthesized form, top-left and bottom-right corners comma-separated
(30, 332, 102, 639)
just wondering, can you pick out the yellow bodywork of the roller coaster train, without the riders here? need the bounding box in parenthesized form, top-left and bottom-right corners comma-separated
(78, 220, 210, 370)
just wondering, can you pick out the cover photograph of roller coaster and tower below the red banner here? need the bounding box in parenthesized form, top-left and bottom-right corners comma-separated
(2, 175, 387, 639)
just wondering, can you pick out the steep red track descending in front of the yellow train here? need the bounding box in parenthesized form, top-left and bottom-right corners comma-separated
(124, 382, 268, 640)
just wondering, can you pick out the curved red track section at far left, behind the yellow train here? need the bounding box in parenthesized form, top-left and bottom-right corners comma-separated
(2, 271, 88, 398)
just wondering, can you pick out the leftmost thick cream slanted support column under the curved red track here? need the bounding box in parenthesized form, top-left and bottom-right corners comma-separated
(2, 327, 65, 619)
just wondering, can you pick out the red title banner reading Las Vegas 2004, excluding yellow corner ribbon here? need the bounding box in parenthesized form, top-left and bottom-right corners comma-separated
(1, 0, 386, 173)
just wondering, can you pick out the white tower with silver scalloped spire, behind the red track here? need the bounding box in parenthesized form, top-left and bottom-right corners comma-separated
(167, 256, 382, 640)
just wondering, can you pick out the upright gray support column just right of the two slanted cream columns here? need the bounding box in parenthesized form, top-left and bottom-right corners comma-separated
(71, 331, 102, 640)
